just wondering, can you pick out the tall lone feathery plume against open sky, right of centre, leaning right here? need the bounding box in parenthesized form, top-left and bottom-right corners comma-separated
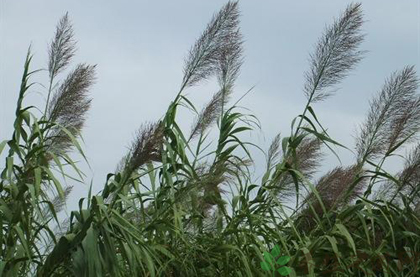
(304, 4, 364, 102)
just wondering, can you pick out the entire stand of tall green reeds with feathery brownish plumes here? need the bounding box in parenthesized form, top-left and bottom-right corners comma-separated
(0, 2, 420, 276)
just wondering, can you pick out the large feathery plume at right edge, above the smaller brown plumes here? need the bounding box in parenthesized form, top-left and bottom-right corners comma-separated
(356, 66, 420, 160)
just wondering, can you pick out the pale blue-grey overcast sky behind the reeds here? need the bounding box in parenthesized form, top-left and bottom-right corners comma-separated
(0, 0, 420, 208)
